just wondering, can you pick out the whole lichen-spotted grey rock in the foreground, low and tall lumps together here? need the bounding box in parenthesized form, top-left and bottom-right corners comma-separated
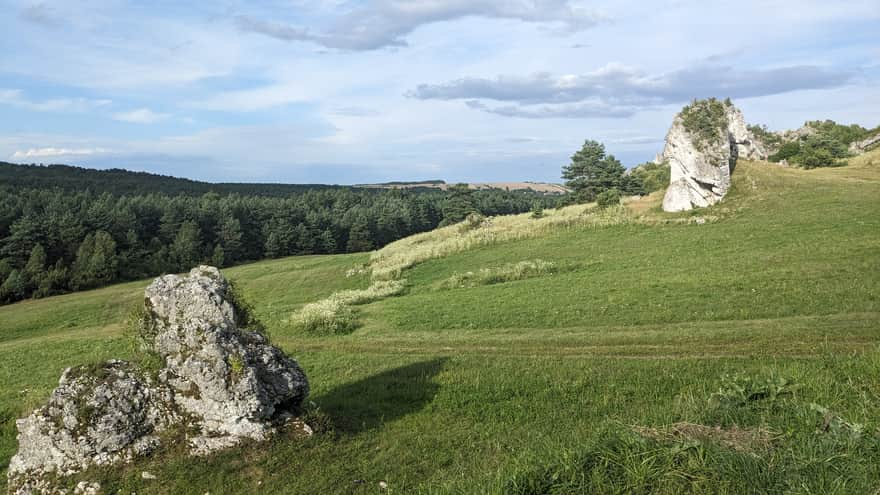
(8, 266, 309, 493)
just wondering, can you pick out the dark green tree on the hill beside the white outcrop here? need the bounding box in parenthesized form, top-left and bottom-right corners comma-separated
(562, 140, 644, 202)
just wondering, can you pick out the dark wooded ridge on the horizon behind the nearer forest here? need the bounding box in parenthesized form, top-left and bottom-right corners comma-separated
(0, 162, 347, 196)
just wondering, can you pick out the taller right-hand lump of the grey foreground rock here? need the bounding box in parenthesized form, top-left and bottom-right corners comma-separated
(145, 266, 309, 444)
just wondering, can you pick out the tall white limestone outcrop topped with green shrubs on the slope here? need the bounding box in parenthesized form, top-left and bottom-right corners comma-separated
(658, 98, 767, 211)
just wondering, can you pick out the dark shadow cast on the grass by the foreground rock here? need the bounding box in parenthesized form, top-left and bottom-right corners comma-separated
(314, 358, 446, 433)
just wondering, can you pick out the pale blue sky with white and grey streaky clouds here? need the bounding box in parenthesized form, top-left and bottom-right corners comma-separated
(0, 0, 880, 184)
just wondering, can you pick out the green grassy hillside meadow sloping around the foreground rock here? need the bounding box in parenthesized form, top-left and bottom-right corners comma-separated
(0, 152, 880, 494)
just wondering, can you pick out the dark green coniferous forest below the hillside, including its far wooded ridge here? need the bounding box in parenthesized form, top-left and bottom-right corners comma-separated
(0, 163, 559, 303)
